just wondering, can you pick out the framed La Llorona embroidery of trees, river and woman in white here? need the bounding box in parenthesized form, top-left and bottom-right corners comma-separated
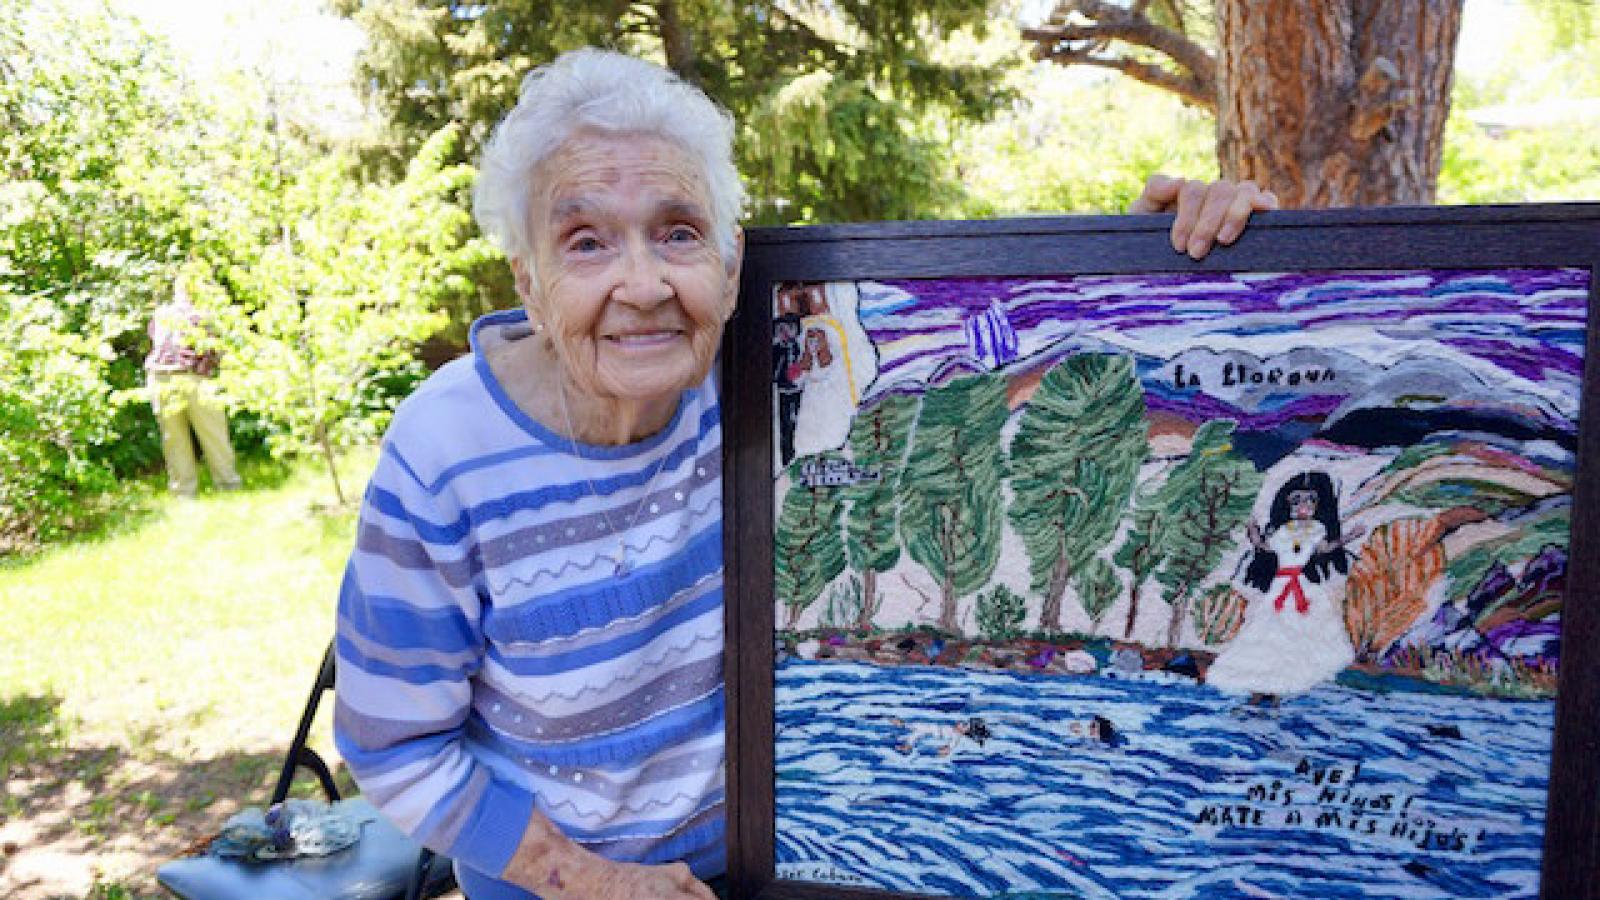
(723, 205, 1600, 898)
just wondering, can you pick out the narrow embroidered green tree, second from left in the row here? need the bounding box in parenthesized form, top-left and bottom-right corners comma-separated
(845, 394, 917, 631)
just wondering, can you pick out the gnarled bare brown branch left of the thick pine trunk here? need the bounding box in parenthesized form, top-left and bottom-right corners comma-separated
(1022, 0, 1216, 110)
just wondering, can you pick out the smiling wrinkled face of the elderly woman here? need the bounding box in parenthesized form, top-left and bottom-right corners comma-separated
(512, 131, 742, 402)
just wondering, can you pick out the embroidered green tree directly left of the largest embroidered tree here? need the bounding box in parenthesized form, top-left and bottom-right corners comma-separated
(899, 375, 1008, 634)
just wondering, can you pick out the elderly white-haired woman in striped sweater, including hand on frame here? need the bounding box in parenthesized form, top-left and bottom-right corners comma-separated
(334, 50, 1274, 900)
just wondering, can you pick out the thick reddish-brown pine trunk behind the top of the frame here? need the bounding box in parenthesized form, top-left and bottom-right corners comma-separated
(1216, 0, 1464, 207)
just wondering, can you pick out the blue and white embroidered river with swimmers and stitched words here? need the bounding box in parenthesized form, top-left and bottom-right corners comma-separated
(776, 658, 1554, 898)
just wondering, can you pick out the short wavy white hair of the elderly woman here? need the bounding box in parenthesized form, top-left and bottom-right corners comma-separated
(472, 46, 744, 271)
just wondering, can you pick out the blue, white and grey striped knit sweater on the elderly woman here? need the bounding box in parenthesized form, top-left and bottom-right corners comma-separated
(334, 312, 723, 876)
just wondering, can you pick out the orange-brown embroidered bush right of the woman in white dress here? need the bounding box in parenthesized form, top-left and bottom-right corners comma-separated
(1344, 519, 1445, 661)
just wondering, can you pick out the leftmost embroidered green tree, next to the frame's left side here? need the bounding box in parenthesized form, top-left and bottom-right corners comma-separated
(773, 453, 845, 631)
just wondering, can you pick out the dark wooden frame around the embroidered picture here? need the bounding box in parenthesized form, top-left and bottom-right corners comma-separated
(723, 203, 1600, 900)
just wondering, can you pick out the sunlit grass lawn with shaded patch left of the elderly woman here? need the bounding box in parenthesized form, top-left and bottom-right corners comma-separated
(0, 452, 387, 900)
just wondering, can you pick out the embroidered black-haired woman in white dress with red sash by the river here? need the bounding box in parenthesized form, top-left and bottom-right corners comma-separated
(1205, 472, 1362, 700)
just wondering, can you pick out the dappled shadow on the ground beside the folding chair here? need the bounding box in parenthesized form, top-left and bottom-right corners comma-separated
(0, 685, 355, 897)
